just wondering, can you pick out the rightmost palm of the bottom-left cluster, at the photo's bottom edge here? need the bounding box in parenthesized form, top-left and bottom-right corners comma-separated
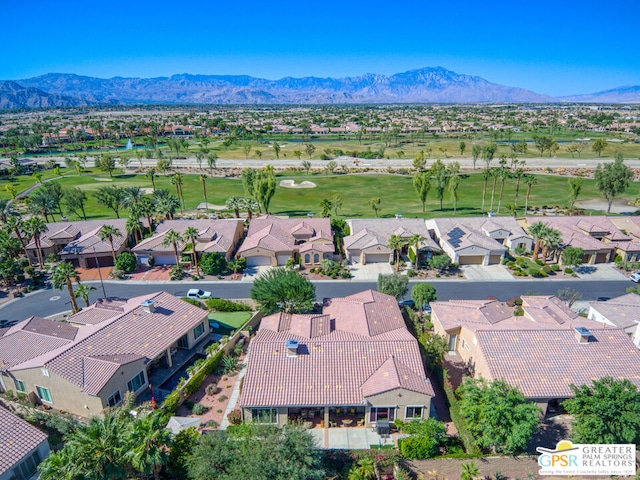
(125, 414, 171, 480)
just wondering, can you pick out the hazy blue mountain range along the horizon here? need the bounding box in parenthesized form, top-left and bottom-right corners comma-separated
(0, 67, 640, 109)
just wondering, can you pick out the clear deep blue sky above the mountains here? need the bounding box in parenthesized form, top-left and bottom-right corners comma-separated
(0, 0, 640, 95)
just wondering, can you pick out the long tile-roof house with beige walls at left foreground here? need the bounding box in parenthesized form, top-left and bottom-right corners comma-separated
(0, 292, 209, 417)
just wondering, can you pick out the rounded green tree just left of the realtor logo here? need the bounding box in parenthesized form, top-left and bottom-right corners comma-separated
(458, 378, 540, 455)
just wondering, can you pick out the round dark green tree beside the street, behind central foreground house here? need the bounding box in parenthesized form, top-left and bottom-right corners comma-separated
(250, 267, 316, 315)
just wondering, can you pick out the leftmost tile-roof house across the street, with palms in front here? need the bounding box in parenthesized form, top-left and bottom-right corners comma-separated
(26, 218, 129, 268)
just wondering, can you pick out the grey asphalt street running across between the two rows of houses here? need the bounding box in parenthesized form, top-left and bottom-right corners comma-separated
(0, 279, 631, 321)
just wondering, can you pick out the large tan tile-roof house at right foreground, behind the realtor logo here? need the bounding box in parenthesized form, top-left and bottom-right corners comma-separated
(431, 296, 640, 410)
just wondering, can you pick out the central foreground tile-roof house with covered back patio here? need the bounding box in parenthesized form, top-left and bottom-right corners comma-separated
(240, 290, 434, 426)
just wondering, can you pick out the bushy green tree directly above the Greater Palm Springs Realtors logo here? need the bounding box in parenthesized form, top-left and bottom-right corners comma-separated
(562, 377, 640, 444)
